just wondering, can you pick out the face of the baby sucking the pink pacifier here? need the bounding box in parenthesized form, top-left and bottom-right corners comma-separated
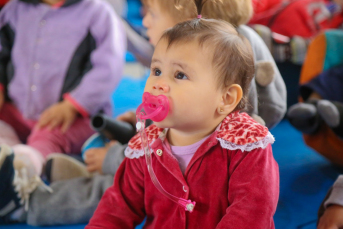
(145, 39, 222, 134)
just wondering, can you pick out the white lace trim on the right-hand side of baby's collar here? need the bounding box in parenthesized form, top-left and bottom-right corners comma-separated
(217, 132, 275, 152)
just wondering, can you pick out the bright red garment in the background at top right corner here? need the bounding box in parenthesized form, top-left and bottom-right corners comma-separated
(249, 0, 343, 38)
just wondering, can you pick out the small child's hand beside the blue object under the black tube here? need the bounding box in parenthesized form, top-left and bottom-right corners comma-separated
(84, 141, 116, 173)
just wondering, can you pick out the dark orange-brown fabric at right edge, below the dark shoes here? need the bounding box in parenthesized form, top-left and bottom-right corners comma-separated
(303, 124, 343, 166)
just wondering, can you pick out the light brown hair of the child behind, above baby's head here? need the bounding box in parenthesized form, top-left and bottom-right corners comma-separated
(142, 0, 253, 27)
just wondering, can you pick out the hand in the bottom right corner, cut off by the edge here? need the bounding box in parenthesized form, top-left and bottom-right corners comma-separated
(317, 205, 343, 229)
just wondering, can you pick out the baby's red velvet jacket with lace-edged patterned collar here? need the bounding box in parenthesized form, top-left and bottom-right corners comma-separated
(86, 113, 279, 229)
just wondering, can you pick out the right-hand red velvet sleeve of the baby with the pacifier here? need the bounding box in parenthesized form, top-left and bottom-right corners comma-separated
(216, 145, 279, 229)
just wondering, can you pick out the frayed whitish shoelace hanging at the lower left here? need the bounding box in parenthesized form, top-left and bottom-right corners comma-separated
(13, 167, 53, 211)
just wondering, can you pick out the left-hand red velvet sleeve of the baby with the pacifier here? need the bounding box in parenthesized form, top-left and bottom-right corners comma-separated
(86, 158, 145, 229)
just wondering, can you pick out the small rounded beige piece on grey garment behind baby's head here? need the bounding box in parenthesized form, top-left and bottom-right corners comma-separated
(255, 61, 275, 87)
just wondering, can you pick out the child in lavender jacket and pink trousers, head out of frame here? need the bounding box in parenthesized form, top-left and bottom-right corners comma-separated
(0, 0, 126, 222)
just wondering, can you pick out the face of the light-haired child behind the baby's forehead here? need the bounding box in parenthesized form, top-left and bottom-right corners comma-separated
(143, 0, 176, 46)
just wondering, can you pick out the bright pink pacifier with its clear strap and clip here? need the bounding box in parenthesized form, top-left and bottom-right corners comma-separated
(136, 92, 195, 212)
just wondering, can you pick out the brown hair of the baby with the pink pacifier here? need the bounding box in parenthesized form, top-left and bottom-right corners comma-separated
(161, 18, 254, 110)
